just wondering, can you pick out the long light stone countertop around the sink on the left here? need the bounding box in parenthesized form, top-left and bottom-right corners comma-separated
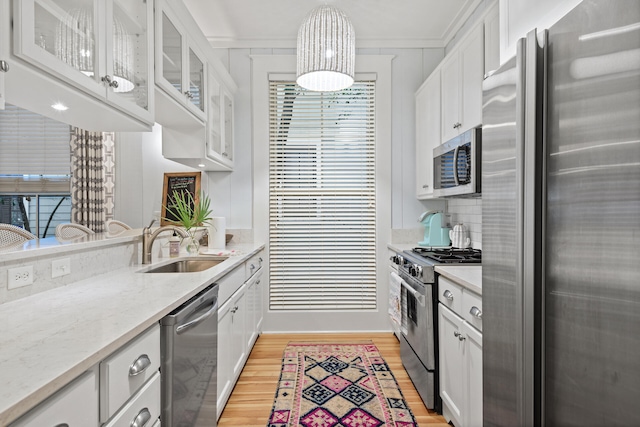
(0, 244, 264, 426)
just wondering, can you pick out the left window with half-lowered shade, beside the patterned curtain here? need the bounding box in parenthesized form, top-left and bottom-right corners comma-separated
(0, 104, 71, 237)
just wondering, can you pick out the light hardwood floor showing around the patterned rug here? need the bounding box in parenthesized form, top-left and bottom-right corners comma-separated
(218, 333, 450, 427)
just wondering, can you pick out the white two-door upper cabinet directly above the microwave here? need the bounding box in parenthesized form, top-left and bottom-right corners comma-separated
(441, 25, 484, 142)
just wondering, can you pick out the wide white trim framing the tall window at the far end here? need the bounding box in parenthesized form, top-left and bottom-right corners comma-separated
(251, 55, 394, 332)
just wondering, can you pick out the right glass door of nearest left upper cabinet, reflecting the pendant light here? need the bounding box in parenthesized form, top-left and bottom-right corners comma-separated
(105, 0, 154, 120)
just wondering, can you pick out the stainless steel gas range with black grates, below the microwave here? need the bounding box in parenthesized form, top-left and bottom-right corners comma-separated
(391, 247, 482, 413)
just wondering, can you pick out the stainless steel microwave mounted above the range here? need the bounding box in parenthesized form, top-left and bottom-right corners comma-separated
(433, 128, 482, 197)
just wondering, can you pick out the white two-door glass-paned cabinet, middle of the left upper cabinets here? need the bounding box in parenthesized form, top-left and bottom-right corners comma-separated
(155, 0, 207, 125)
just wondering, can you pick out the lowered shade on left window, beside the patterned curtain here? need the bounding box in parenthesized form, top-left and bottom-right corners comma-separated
(0, 104, 71, 192)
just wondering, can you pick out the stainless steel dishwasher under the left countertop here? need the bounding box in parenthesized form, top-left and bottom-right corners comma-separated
(160, 284, 218, 427)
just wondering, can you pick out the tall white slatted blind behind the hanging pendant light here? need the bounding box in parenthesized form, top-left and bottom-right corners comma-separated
(269, 81, 376, 310)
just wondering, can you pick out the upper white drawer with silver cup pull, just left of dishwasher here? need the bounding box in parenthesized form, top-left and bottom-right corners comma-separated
(100, 325, 160, 422)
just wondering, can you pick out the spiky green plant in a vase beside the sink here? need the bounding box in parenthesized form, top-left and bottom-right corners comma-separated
(165, 190, 212, 255)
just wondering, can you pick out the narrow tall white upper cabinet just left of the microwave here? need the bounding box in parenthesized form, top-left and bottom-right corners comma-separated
(416, 68, 440, 199)
